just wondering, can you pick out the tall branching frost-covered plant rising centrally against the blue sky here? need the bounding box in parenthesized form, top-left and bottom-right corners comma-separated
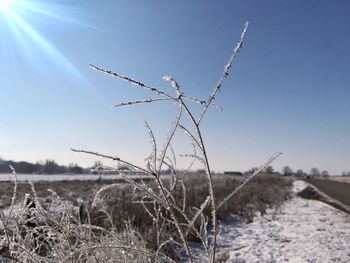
(72, 22, 279, 263)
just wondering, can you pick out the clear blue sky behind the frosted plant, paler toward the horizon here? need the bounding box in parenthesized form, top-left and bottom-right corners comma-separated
(0, 0, 350, 174)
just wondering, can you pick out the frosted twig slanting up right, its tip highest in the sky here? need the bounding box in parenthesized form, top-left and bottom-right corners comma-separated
(197, 21, 249, 125)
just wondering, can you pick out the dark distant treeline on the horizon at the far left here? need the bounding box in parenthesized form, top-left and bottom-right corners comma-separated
(0, 159, 90, 174)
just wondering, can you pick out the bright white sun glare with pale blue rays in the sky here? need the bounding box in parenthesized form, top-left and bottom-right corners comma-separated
(0, 0, 83, 79)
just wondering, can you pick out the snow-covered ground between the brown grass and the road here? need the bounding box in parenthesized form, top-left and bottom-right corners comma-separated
(209, 181, 350, 263)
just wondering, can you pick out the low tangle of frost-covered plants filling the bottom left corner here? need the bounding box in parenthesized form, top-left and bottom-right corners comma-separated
(0, 169, 172, 263)
